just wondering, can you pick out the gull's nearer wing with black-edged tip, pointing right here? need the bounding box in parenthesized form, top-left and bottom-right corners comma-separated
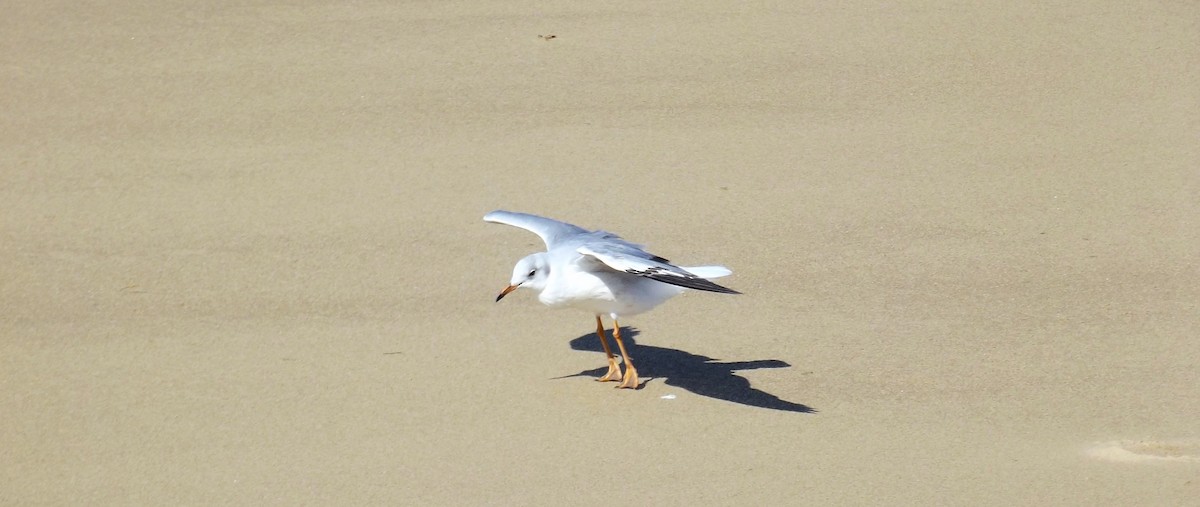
(576, 239, 740, 294)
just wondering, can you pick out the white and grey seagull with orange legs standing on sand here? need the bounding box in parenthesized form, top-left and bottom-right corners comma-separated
(484, 210, 740, 389)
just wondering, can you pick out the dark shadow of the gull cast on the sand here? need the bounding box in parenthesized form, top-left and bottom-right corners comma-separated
(559, 326, 816, 413)
